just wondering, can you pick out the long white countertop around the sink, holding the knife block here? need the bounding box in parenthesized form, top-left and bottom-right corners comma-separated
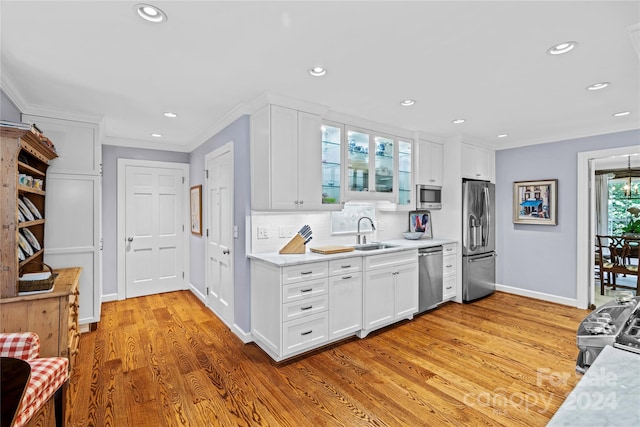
(247, 239, 457, 267)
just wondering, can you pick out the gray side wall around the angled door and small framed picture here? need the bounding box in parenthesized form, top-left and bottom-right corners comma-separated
(189, 116, 251, 332)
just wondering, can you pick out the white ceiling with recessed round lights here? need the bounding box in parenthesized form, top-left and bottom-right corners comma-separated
(0, 0, 640, 151)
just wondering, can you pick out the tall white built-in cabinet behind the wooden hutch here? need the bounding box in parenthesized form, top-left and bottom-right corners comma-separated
(22, 114, 102, 325)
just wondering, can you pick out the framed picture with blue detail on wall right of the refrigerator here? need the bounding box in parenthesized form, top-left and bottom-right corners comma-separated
(513, 179, 558, 225)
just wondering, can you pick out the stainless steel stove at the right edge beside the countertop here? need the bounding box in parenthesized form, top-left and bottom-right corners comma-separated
(576, 291, 640, 373)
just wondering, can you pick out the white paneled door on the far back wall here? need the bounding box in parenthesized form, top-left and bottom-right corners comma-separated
(124, 165, 186, 298)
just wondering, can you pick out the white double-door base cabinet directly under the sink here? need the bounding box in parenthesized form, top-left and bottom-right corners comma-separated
(359, 250, 418, 338)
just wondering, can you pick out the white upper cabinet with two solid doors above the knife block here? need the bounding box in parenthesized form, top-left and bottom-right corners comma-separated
(250, 105, 340, 211)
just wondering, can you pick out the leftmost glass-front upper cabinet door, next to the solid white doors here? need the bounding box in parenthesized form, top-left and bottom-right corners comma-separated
(321, 122, 344, 207)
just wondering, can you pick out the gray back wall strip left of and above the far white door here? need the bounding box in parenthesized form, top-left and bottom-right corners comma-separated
(102, 145, 189, 295)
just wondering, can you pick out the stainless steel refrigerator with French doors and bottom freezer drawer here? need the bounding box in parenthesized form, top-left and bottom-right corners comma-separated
(462, 179, 496, 302)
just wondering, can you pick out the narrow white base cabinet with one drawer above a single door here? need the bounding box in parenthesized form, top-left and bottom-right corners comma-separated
(329, 257, 362, 340)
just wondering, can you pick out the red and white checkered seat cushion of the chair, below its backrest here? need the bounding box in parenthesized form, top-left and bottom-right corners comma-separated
(14, 357, 69, 427)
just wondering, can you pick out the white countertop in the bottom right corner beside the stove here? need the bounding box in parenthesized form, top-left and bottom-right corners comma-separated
(547, 346, 640, 427)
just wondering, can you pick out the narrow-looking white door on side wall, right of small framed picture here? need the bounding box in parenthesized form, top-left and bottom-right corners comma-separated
(205, 143, 234, 327)
